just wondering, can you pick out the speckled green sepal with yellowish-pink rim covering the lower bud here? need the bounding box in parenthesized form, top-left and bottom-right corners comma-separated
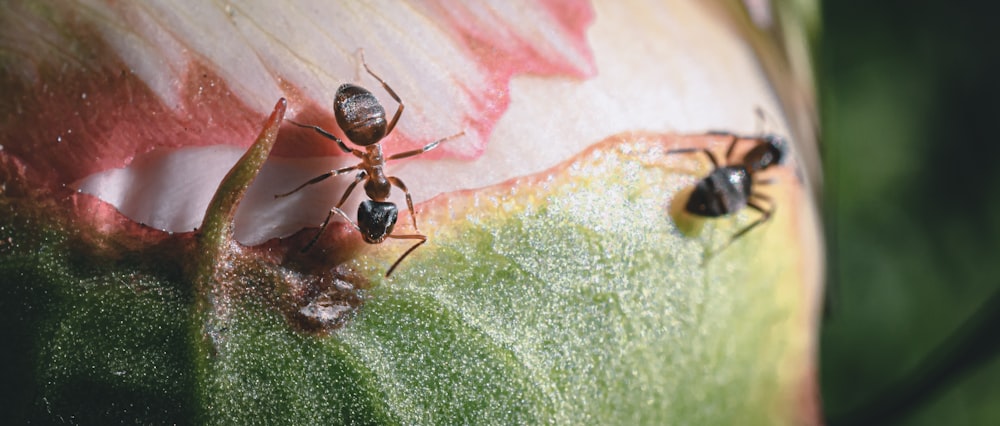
(0, 135, 812, 424)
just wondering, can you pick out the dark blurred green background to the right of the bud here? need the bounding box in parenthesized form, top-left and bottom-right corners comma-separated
(816, 0, 1000, 425)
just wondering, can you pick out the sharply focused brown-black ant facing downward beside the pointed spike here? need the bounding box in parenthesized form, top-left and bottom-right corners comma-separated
(274, 54, 465, 278)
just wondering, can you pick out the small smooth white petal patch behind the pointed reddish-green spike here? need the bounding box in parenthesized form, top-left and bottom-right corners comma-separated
(73, 145, 360, 245)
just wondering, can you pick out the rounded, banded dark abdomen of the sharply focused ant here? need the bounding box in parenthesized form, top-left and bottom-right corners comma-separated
(333, 84, 387, 146)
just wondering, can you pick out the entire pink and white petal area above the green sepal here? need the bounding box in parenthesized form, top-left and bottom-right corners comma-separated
(0, 1, 804, 244)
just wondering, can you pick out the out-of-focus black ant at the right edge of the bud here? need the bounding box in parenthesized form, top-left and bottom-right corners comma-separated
(667, 108, 788, 251)
